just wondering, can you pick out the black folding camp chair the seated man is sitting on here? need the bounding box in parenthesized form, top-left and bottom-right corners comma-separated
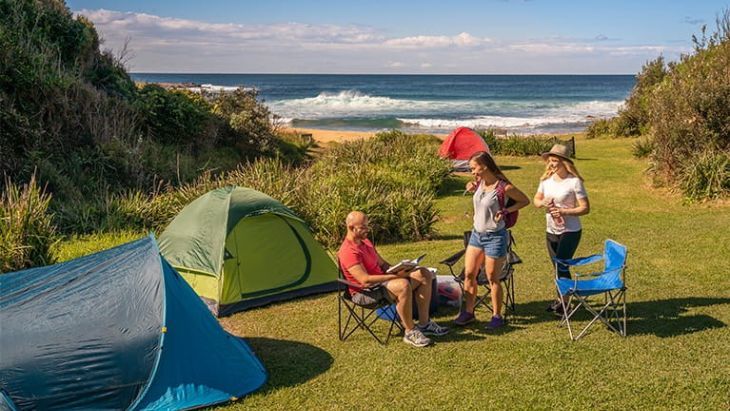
(337, 261, 403, 345)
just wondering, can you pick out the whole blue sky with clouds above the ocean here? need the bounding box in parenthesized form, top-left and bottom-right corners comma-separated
(67, 0, 730, 74)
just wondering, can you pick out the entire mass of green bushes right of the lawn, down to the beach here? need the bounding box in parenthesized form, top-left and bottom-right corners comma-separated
(588, 9, 730, 201)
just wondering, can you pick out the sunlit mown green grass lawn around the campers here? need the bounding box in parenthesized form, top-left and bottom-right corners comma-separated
(58, 140, 730, 410)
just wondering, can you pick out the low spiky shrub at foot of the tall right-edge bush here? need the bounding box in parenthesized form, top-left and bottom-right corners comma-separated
(680, 151, 730, 200)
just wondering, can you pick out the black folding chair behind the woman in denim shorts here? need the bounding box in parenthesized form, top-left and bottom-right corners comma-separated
(440, 230, 522, 316)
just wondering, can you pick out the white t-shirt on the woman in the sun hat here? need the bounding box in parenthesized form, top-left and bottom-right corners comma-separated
(537, 174, 588, 234)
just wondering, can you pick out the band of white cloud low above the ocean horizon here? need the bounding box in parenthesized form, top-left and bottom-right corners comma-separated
(77, 9, 688, 73)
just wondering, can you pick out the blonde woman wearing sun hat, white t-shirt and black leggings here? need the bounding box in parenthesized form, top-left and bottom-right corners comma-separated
(533, 144, 591, 313)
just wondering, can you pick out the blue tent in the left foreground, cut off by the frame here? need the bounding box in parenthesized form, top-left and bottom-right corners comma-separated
(0, 236, 267, 410)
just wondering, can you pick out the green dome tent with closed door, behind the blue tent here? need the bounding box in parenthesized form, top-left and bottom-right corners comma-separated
(160, 187, 337, 316)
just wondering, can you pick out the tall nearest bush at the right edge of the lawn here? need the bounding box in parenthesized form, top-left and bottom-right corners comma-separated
(650, 11, 730, 200)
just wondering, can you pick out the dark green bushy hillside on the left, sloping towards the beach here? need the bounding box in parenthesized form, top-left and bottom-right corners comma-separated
(0, 0, 306, 225)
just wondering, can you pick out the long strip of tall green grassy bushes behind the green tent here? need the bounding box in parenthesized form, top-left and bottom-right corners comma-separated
(114, 132, 450, 246)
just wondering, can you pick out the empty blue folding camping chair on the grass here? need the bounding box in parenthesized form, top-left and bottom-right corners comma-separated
(553, 240, 627, 341)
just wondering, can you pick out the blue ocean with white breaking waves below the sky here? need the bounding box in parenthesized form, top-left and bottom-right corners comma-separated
(132, 73, 635, 134)
